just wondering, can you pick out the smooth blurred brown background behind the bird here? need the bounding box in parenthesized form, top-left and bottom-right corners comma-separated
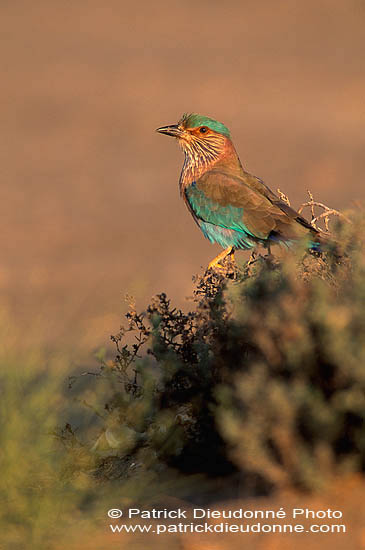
(0, 0, 365, 346)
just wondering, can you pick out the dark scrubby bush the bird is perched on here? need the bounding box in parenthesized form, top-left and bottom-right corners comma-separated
(71, 215, 365, 494)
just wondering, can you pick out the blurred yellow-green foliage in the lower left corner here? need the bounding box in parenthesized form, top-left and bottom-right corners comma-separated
(0, 348, 115, 550)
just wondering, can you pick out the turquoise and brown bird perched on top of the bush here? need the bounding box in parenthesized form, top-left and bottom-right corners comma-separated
(156, 113, 322, 270)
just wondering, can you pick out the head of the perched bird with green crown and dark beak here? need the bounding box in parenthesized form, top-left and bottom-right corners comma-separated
(156, 113, 230, 162)
